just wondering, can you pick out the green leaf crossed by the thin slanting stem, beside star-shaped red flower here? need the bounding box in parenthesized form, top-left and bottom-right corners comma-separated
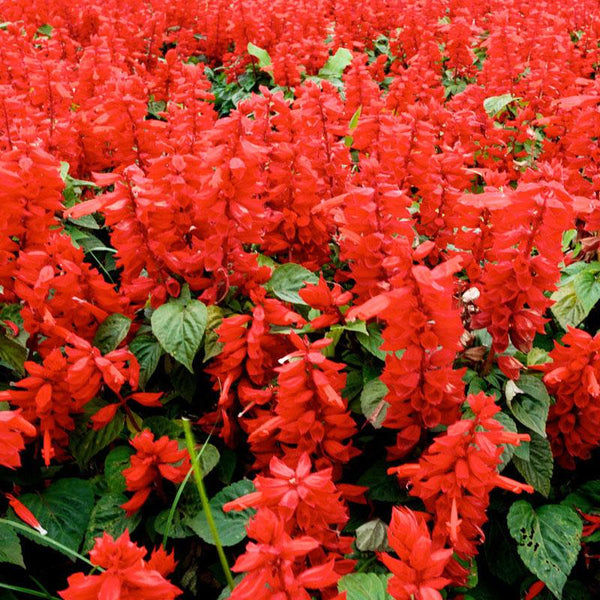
(185, 479, 255, 546)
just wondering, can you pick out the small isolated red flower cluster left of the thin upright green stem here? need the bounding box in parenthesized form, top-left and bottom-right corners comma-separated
(122, 429, 190, 515)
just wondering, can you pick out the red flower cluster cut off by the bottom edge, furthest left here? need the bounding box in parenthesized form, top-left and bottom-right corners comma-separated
(59, 531, 182, 600)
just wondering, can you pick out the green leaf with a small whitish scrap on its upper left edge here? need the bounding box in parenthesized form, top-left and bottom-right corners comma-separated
(506, 375, 550, 437)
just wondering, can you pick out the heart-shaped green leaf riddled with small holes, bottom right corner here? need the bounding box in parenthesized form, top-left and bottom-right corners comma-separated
(507, 500, 582, 598)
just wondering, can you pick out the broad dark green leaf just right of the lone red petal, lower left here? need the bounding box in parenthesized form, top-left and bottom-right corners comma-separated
(13, 478, 94, 551)
